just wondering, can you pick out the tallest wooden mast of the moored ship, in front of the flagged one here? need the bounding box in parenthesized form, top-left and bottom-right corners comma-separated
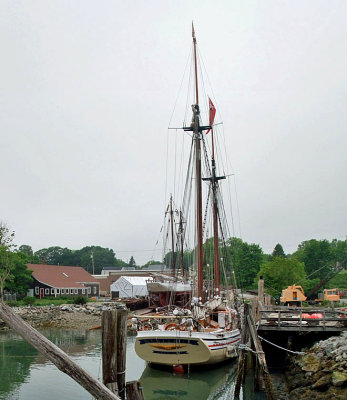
(192, 24, 204, 300)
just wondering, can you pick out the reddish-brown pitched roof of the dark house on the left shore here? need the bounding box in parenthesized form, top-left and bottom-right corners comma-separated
(28, 264, 98, 288)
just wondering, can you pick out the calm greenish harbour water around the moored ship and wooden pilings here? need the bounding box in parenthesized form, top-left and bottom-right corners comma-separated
(0, 330, 264, 400)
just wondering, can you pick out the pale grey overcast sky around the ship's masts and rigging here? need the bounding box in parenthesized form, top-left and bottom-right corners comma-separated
(0, 0, 347, 263)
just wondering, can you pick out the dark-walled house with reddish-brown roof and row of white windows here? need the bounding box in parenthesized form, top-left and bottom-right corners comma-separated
(28, 264, 100, 298)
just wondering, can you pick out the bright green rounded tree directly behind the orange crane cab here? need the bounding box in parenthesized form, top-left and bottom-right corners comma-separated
(255, 257, 306, 296)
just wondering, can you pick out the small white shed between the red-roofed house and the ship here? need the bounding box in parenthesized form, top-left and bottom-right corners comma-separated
(110, 276, 152, 299)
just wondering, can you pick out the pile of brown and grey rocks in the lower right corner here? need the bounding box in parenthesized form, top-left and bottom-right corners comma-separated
(285, 332, 347, 400)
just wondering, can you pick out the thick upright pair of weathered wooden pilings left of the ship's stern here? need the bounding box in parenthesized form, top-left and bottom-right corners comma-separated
(102, 309, 128, 399)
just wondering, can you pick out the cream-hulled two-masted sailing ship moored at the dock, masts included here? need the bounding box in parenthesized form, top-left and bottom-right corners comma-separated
(133, 27, 240, 365)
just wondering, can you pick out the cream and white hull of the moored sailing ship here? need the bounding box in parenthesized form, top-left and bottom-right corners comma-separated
(135, 329, 240, 365)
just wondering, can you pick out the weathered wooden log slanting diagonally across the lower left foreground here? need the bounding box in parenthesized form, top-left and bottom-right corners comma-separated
(0, 300, 120, 400)
